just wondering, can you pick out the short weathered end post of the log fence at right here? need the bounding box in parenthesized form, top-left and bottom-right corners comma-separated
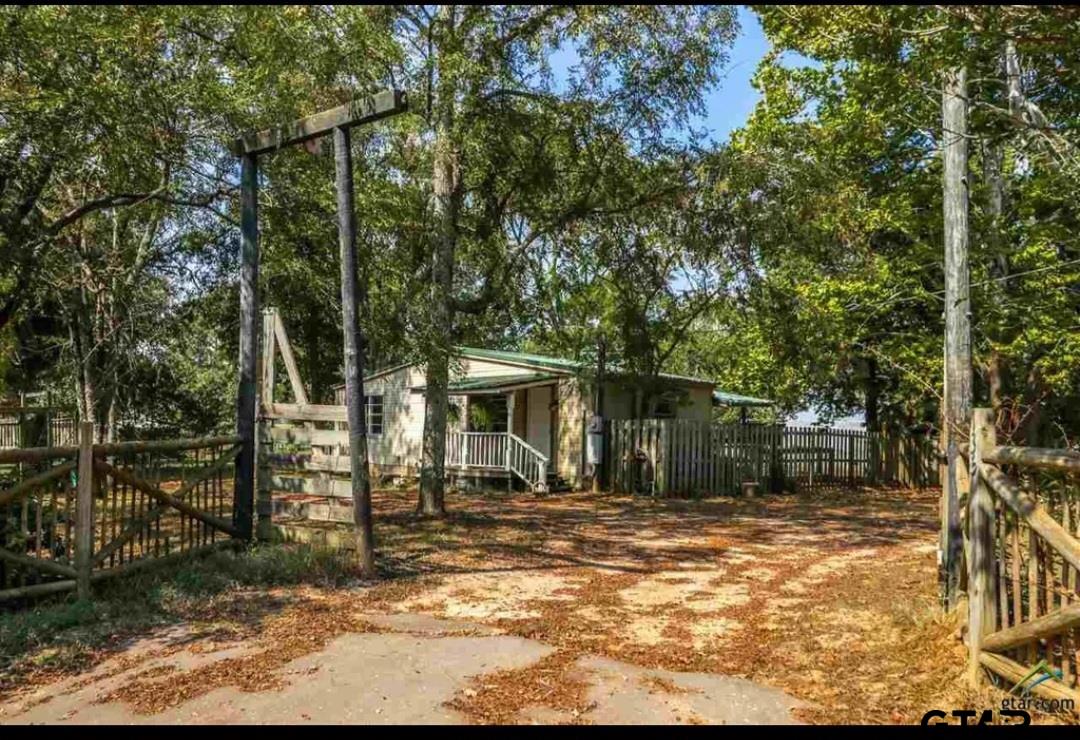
(968, 408, 997, 688)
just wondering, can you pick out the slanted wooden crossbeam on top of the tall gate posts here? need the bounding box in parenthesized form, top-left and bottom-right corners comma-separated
(232, 90, 408, 157)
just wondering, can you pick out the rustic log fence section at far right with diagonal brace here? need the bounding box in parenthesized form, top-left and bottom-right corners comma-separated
(967, 408, 1080, 711)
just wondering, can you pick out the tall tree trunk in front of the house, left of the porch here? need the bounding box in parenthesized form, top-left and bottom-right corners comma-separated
(417, 5, 460, 516)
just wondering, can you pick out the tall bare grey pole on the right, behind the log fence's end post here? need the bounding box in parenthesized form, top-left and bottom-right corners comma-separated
(939, 67, 972, 609)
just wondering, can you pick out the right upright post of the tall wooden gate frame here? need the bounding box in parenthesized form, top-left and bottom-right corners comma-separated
(334, 126, 375, 578)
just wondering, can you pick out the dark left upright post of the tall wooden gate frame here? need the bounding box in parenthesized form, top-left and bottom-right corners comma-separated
(232, 152, 259, 540)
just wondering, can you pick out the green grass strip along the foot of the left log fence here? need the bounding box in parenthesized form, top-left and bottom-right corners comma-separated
(0, 544, 356, 697)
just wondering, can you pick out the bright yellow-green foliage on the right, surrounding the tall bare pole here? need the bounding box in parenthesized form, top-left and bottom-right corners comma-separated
(673, 5, 1080, 439)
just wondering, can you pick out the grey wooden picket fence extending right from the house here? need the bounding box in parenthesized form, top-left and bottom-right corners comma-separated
(605, 419, 937, 496)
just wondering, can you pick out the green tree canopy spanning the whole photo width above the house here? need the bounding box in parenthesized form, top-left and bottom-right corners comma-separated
(0, 5, 1080, 449)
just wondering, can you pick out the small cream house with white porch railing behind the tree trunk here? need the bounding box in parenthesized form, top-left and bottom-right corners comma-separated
(335, 347, 760, 489)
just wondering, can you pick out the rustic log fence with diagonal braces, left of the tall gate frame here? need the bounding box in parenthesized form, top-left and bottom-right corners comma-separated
(0, 425, 241, 602)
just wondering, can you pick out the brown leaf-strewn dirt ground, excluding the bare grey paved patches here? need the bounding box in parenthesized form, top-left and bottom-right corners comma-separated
(0, 489, 1062, 724)
